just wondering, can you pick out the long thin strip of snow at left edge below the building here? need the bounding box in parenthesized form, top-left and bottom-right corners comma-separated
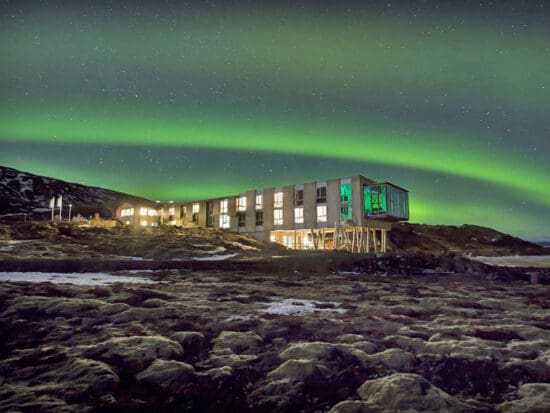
(0, 272, 155, 285)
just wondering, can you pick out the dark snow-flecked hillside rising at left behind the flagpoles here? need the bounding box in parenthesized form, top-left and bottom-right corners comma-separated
(0, 166, 152, 218)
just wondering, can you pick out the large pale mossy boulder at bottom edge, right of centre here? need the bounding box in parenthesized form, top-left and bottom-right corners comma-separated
(357, 373, 472, 412)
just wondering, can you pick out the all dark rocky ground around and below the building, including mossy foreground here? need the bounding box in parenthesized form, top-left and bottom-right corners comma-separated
(0, 222, 550, 413)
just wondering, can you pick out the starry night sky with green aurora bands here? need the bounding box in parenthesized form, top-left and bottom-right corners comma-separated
(0, 1, 550, 238)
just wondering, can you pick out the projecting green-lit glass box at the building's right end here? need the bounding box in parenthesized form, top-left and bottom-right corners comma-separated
(363, 183, 409, 219)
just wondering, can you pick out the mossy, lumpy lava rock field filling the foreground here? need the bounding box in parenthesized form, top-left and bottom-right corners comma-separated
(0, 271, 550, 413)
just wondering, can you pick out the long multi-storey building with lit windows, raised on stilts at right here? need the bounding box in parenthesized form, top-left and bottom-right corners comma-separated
(117, 175, 409, 253)
